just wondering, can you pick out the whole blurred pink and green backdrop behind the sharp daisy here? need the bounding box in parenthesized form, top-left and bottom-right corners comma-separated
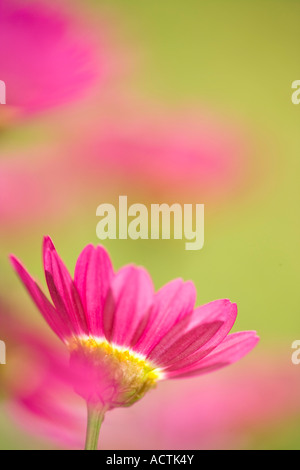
(0, 0, 300, 449)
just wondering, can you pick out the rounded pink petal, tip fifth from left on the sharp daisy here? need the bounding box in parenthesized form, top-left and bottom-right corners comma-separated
(134, 279, 196, 356)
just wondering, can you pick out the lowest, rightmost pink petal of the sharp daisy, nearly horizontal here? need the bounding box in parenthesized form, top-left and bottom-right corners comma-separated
(167, 331, 259, 378)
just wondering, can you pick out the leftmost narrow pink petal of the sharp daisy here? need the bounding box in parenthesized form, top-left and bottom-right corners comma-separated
(10, 256, 72, 341)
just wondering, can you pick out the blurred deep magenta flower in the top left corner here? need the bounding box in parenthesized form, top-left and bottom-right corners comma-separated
(0, 0, 102, 121)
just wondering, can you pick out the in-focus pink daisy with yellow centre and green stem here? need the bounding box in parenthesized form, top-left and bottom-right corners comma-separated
(11, 237, 258, 448)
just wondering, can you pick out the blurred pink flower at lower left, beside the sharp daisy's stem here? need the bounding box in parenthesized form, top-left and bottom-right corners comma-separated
(0, 301, 86, 444)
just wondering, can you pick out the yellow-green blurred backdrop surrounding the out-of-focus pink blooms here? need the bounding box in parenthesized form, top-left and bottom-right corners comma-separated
(0, 0, 300, 448)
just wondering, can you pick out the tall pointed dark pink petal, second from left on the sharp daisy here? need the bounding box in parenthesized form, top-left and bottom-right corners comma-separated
(43, 237, 88, 335)
